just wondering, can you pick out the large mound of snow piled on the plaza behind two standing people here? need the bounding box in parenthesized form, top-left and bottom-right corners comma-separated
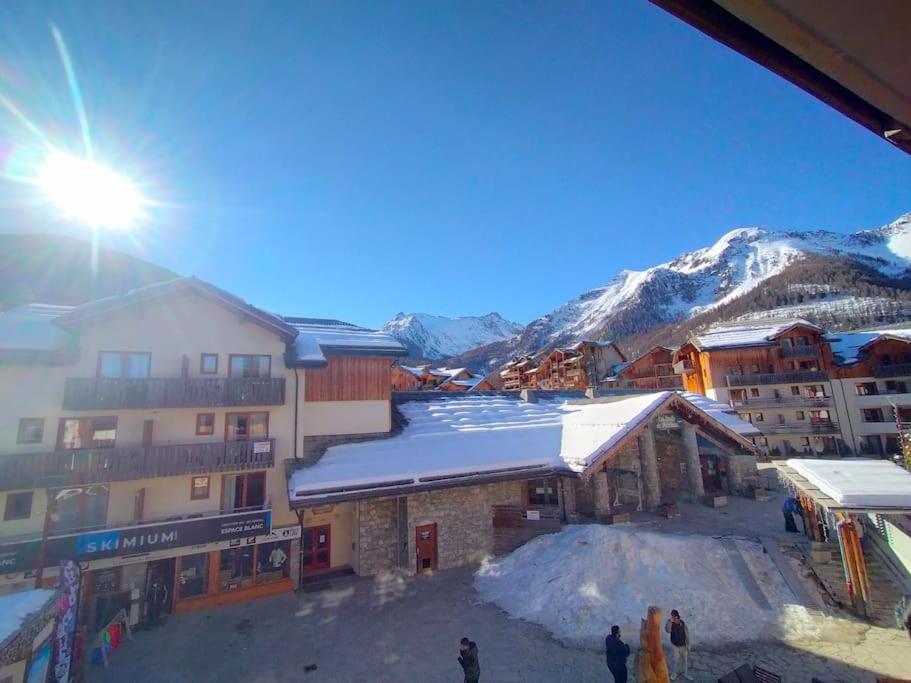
(475, 525, 840, 648)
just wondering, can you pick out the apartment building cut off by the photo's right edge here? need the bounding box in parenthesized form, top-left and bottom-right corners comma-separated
(826, 326, 911, 457)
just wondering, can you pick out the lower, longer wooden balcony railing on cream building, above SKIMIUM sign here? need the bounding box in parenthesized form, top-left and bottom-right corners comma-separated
(0, 439, 275, 491)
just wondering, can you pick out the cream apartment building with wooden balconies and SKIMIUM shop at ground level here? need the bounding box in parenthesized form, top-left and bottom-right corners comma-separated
(0, 278, 405, 631)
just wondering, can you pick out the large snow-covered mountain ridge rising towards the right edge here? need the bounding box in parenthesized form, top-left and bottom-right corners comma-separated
(454, 213, 911, 369)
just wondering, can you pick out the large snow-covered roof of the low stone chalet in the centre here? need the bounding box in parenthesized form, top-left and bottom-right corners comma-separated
(288, 391, 756, 502)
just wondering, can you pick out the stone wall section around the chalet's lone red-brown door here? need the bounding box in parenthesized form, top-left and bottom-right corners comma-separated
(408, 481, 526, 572)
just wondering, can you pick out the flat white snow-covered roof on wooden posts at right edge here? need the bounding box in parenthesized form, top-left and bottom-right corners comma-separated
(787, 458, 911, 510)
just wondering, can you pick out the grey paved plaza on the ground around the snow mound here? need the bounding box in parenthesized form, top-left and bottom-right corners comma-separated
(87, 484, 911, 683)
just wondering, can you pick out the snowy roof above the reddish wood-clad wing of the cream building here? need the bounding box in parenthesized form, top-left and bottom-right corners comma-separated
(285, 318, 408, 366)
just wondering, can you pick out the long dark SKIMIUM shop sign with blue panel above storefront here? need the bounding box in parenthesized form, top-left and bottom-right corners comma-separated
(0, 510, 272, 573)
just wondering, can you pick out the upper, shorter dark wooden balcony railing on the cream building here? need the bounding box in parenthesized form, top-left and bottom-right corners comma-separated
(63, 377, 285, 410)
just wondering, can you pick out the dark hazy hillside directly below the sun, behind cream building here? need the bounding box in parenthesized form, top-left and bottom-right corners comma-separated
(0, 234, 177, 310)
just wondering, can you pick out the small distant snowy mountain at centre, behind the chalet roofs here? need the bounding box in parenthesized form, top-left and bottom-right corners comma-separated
(381, 313, 523, 360)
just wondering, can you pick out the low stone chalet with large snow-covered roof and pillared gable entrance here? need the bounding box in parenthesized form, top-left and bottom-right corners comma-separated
(286, 392, 756, 575)
